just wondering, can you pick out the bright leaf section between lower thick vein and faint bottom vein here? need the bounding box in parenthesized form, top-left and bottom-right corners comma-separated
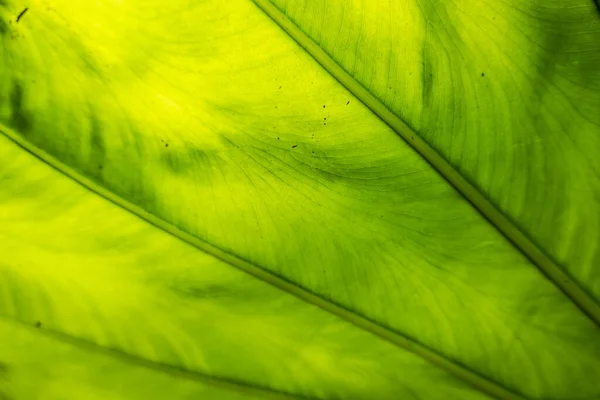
(0, 136, 485, 400)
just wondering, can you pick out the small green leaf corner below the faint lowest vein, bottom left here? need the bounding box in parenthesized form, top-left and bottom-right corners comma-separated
(0, 320, 255, 400)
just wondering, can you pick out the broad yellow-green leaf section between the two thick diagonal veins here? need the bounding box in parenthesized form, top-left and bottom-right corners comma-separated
(3, 2, 598, 395)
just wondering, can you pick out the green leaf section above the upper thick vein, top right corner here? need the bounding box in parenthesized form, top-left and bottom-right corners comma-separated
(266, 0, 600, 304)
